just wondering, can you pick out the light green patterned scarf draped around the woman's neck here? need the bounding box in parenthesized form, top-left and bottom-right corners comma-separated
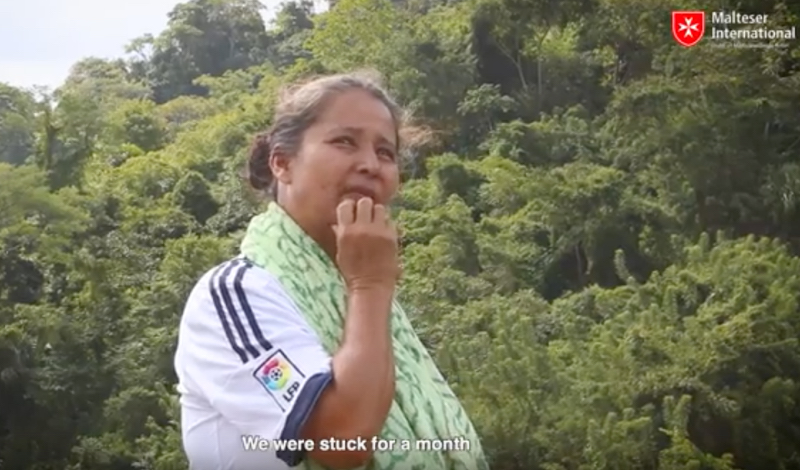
(241, 202, 489, 470)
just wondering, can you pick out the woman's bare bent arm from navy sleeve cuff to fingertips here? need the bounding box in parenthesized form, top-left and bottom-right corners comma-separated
(301, 198, 400, 469)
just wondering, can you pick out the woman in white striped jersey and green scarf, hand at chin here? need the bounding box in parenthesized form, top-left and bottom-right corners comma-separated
(175, 70, 487, 470)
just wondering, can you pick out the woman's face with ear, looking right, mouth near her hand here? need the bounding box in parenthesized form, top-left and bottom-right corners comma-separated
(272, 90, 400, 225)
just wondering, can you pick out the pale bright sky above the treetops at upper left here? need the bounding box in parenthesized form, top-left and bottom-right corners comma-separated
(0, 0, 318, 89)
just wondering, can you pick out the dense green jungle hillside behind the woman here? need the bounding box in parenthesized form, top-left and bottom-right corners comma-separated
(0, 0, 800, 470)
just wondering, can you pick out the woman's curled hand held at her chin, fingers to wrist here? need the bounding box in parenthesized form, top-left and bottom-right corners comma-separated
(333, 197, 400, 292)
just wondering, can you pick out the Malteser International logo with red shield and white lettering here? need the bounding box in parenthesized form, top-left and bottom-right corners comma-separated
(672, 11, 797, 48)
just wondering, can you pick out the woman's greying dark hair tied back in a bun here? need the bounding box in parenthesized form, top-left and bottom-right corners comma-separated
(246, 71, 421, 199)
